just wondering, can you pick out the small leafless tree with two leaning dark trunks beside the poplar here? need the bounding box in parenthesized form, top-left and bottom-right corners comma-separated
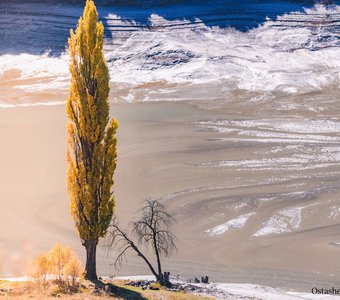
(108, 199, 176, 286)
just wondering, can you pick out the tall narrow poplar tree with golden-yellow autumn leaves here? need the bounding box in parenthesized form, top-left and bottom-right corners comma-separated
(66, 0, 118, 280)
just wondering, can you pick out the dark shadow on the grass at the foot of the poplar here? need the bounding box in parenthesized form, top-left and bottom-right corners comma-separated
(90, 280, 147, 300)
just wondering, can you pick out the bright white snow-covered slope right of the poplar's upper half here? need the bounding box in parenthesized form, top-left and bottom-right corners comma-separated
(108, 5, 340, 92)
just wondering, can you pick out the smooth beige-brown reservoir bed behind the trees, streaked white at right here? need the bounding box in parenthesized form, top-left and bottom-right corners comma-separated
(0, 96, 340, 291)
